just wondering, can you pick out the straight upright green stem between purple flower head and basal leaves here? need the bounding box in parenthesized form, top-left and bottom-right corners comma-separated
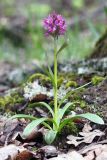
(54, 38, 58, 123)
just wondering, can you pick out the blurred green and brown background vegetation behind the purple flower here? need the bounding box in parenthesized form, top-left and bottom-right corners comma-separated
(0, 0, 107, 63)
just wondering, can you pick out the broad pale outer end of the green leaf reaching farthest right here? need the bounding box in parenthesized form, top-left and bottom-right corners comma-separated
(76, 113, 104, 124)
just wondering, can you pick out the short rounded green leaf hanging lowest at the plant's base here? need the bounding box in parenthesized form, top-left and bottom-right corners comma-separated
(44, 130, 57, 144)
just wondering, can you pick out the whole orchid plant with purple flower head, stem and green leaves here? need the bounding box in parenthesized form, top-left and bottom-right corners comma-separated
(11, 13, 104, 144)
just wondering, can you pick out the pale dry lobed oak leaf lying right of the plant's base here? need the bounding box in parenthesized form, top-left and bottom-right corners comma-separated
(67, 130, 104, 147)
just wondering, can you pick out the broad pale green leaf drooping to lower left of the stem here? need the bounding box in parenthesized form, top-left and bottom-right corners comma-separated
(23, 118, 48, 138)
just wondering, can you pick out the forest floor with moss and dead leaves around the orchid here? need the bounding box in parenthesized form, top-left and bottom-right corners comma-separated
(0, 58, 107, 160)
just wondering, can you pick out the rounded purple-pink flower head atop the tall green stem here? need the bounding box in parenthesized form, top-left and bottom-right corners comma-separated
(43, 12, 67, 38)
